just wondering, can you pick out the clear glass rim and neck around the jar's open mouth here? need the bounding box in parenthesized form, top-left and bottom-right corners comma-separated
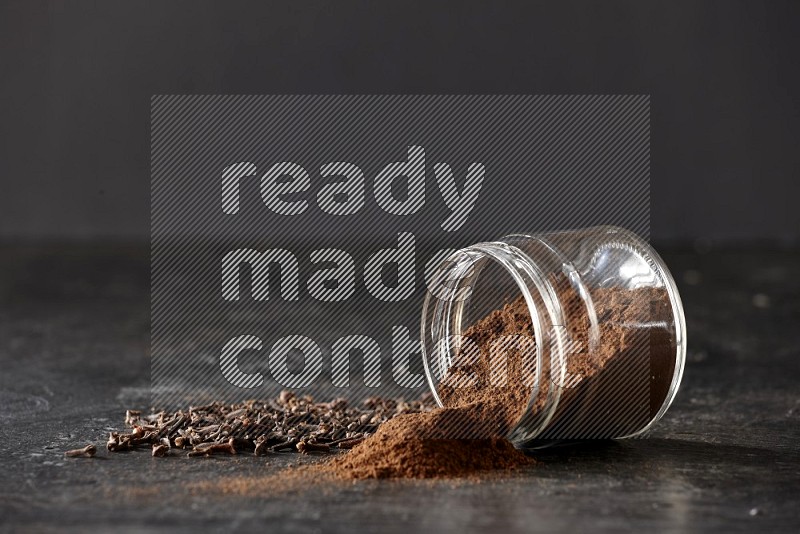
(421, 242, 566, 446)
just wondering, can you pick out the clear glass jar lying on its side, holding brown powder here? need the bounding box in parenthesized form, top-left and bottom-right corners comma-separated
(421, 226, 686, 446)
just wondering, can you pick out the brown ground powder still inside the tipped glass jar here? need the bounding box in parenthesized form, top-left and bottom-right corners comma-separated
(439, 286, 676, 440)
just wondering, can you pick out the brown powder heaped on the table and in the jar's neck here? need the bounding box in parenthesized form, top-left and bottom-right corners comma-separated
(318, 302, 535, 479)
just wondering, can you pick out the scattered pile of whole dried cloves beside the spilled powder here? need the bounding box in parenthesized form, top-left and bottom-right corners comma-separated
(106, 391, 435, 457)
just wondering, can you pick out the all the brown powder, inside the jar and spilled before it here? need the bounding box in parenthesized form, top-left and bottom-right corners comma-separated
(320, 284, 675, 479)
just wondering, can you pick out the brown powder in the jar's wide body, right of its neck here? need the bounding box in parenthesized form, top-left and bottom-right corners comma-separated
(539, 284, 677, 440)
